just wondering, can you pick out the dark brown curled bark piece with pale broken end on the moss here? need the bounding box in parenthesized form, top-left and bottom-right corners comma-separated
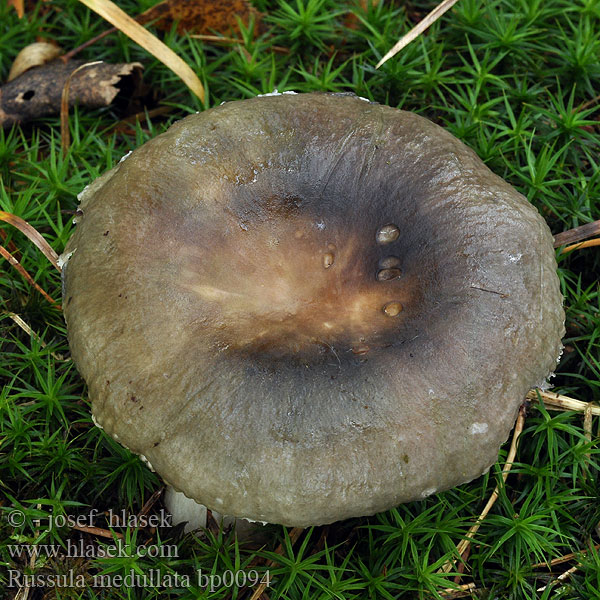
(0, 59, 143, 127)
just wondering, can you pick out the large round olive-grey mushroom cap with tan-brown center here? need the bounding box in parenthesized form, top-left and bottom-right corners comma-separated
(64, 94, 564, 526)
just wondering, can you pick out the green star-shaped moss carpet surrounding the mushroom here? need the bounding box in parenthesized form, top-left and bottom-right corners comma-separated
(0, 0, 600, 600)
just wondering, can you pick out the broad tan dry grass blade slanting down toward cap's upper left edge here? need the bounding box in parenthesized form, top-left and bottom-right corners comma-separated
(79, 0, 204, 102)
